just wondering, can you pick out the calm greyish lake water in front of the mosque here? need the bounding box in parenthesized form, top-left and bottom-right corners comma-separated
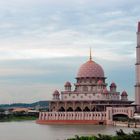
(0, 121, 140, 140)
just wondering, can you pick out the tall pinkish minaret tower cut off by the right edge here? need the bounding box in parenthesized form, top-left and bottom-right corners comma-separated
(135, 22, 140, 112)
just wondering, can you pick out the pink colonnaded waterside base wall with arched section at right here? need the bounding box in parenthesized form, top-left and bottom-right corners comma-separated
(39, 107, 134, 125)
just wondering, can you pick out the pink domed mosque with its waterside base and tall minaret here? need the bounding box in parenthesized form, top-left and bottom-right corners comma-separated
(37, 22, 140, 124)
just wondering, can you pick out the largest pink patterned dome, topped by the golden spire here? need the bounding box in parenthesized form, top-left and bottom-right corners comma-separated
(77, 60, 104, 78)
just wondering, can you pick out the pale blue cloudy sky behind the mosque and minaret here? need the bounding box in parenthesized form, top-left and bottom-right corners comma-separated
(0, 0, 140, 104)
